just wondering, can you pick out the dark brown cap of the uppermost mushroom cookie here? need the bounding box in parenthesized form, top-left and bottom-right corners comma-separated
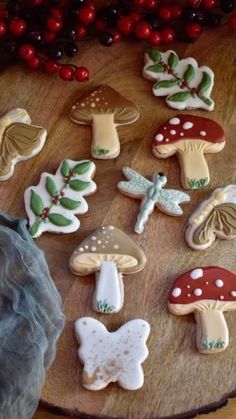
(70, 86, 139, 125)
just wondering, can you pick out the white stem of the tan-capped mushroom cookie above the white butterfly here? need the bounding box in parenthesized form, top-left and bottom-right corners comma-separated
(93, 262, 124, 314)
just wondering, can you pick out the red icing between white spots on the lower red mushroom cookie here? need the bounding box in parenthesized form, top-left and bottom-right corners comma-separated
(168, 266, 236, 304)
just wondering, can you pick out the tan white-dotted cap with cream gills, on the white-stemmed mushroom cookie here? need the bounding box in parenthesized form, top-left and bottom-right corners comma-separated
(69, 225, 146, 275)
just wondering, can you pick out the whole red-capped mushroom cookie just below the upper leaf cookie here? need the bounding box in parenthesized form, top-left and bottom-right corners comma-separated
(152, 114, 226, 189)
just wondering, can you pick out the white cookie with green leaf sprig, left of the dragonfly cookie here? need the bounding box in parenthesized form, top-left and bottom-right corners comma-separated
(24, 160, 96, 238)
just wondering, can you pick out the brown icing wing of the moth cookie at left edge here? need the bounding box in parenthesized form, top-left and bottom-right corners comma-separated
(0, 122, 45, 176)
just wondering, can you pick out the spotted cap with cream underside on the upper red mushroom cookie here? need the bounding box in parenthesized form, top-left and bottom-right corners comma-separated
(153, 114, 226, 153)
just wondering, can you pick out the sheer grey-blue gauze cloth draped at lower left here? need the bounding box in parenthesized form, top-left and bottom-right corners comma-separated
(0, 211, 64, 419)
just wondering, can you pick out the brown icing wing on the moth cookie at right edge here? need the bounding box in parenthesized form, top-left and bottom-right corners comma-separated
(192, 204, 236, 245)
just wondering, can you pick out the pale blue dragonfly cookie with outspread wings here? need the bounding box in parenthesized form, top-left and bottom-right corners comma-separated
(118, 167, 190, 234)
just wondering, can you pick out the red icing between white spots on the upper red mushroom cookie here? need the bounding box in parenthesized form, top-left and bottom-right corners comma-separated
(154, 114, 226, 146)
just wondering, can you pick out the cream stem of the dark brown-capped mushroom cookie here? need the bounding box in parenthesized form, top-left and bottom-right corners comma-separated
(92, 113, 120, 159)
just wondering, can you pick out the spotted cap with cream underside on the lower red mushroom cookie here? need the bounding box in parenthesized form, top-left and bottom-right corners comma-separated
(168, 266, 236, 308)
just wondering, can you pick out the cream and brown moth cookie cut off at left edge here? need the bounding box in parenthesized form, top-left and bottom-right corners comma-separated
(0, 108, 47, 180)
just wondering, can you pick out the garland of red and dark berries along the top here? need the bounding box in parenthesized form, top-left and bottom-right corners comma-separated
(0, 0, 236, 82)
